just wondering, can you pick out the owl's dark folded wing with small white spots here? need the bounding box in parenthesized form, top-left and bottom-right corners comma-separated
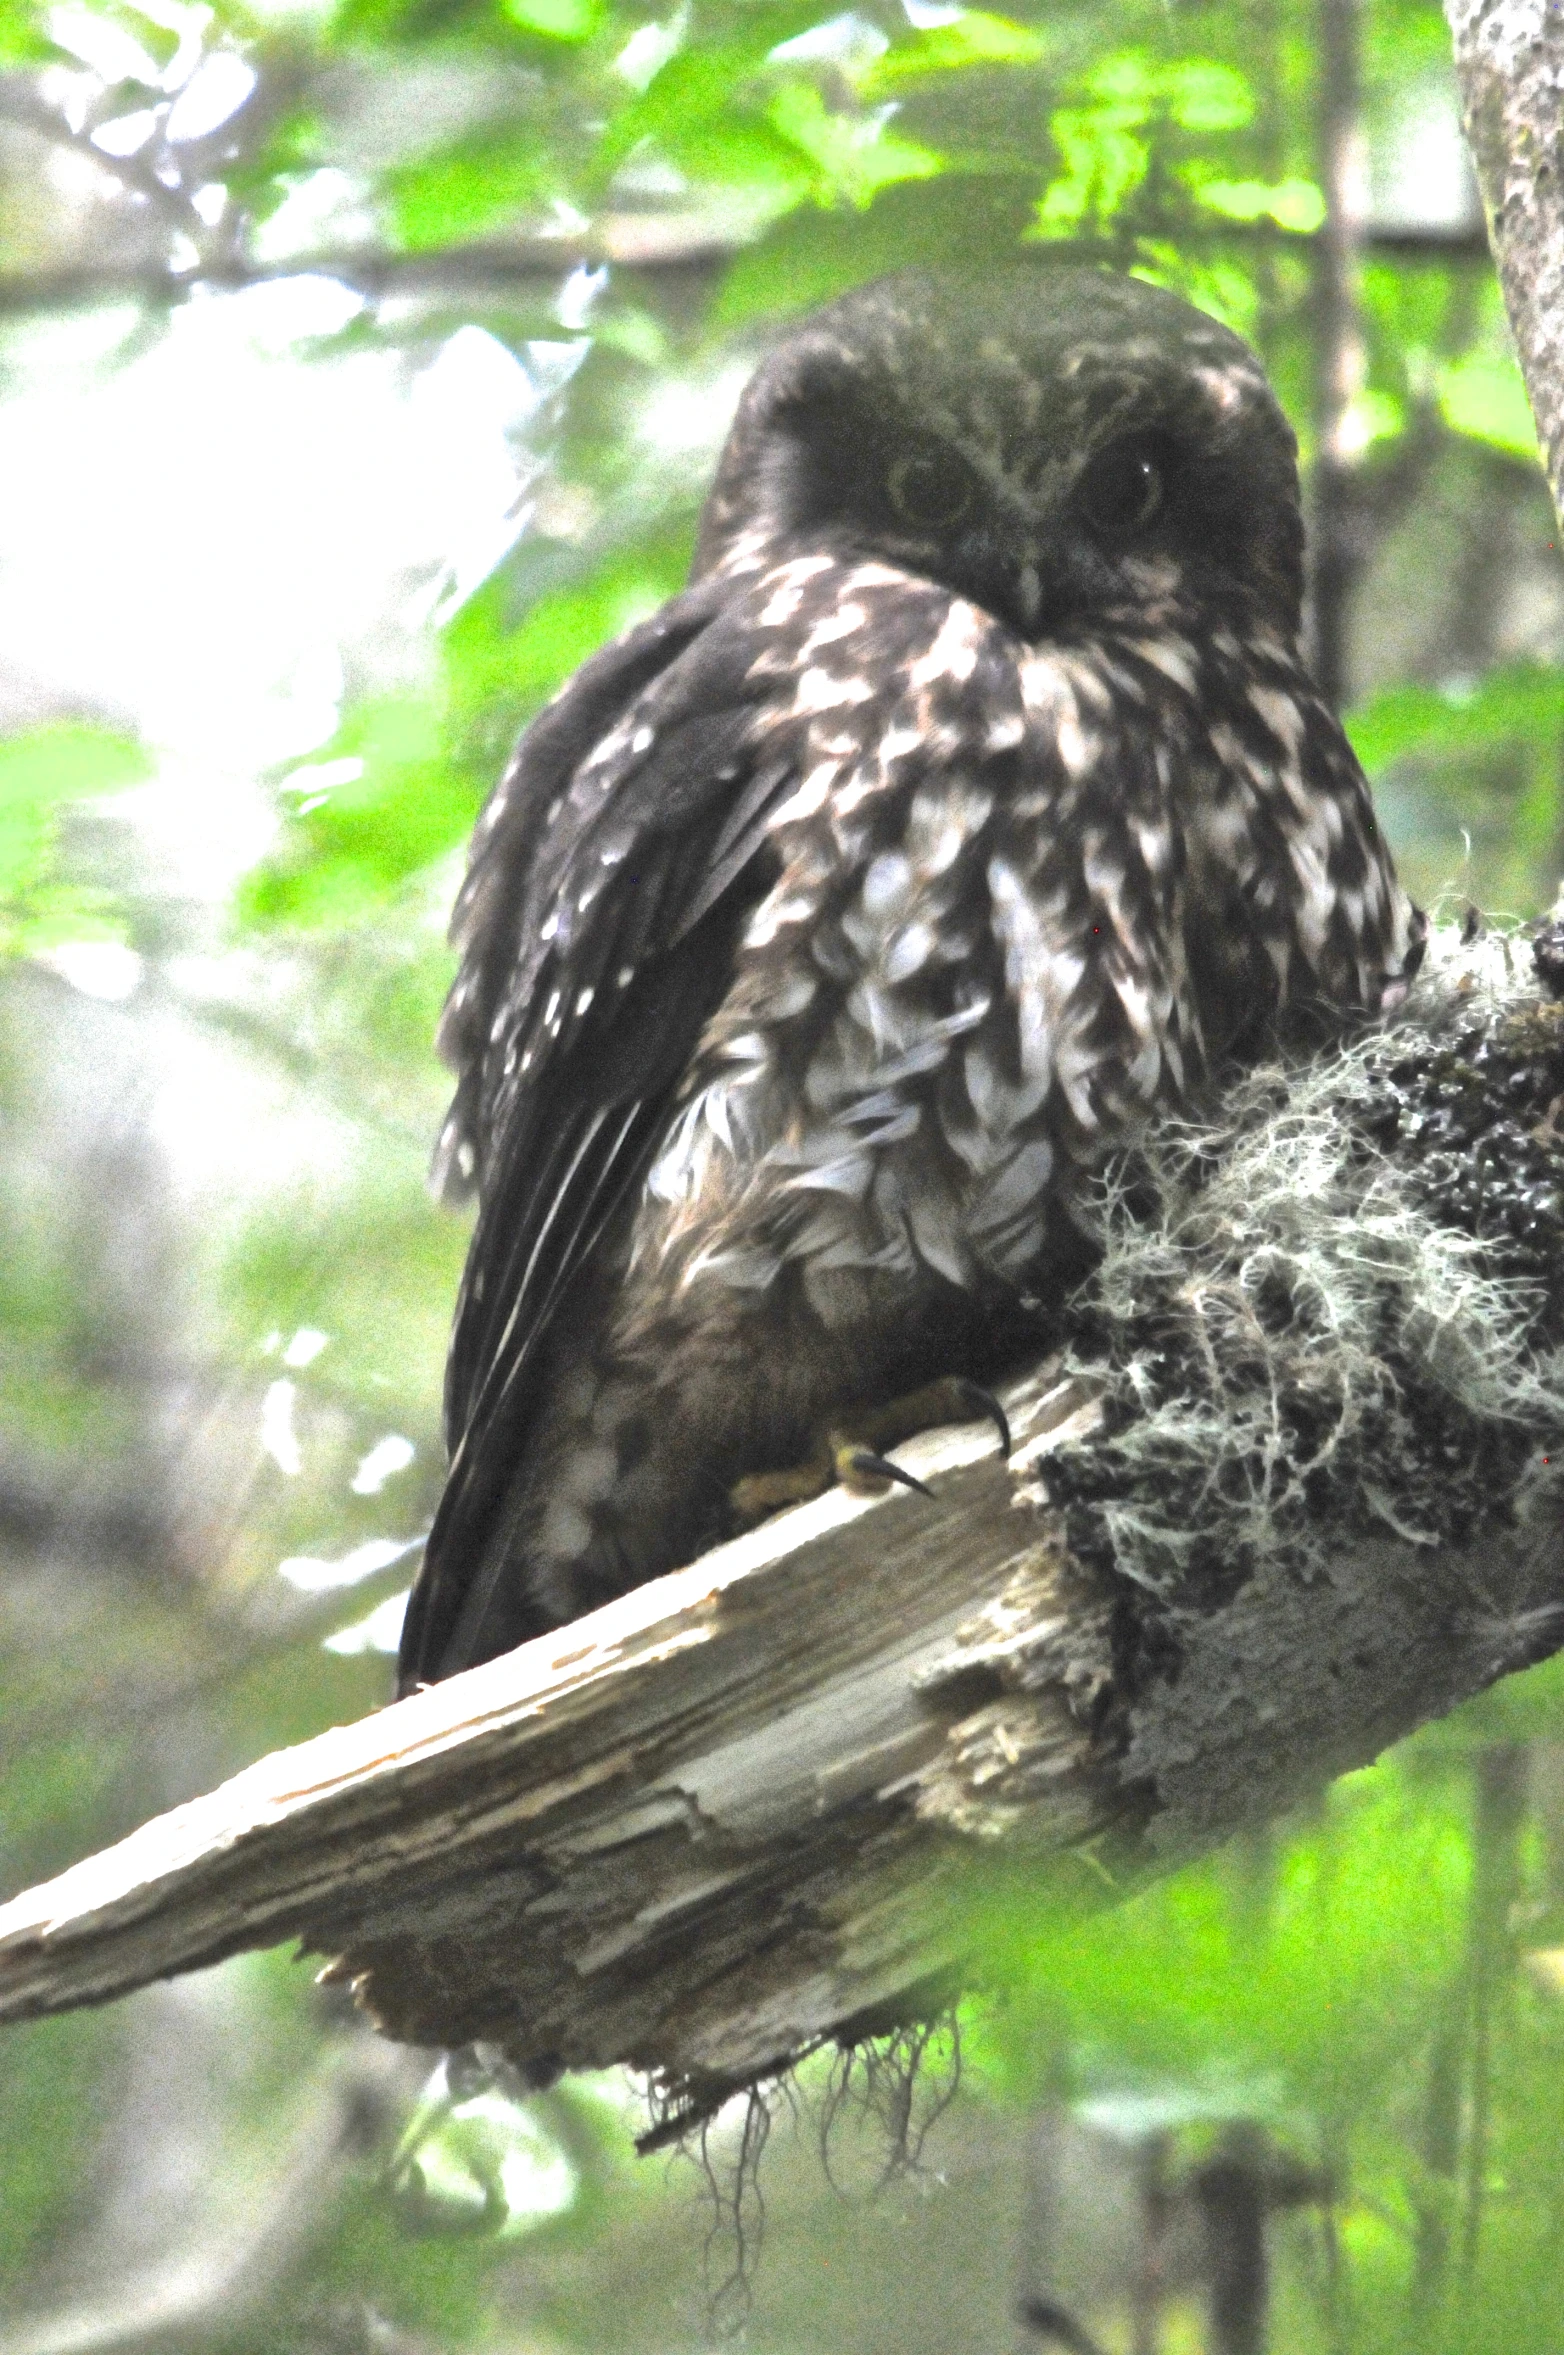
(400, 584, 796, 1689)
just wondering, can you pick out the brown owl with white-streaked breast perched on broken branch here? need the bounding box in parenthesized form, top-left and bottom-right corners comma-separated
(400, 268, 1423, 1689)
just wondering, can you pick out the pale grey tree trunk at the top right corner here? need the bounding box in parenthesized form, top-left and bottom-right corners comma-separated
(1444, 0, 1564, 518)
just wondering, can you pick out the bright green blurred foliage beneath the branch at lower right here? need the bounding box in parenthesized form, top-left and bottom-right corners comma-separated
(970, 1660, 1564, 2355)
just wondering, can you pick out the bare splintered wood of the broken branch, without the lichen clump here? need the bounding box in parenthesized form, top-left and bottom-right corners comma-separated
(0, 1309, 1536, 2115)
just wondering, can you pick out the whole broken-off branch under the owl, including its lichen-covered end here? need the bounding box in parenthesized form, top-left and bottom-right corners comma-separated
(0, 940, 1564, 2117)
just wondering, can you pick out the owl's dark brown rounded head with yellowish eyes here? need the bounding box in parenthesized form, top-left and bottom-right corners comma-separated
(695, 268, 1303, 643)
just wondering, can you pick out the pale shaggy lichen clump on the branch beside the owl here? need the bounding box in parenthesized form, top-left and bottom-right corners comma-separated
(1051, 933, 1564, 1601)
